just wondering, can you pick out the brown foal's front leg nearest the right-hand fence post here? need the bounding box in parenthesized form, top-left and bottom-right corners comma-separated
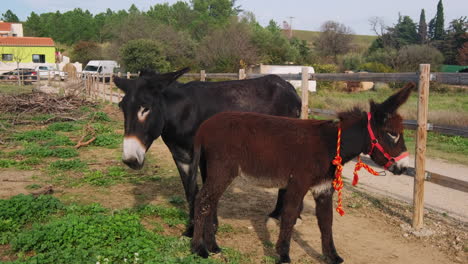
(314, 189, 343, 264)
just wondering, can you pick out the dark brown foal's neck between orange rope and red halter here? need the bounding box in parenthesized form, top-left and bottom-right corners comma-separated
(341, 116, 369, 164)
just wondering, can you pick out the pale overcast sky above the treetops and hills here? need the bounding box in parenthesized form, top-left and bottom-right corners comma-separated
(0, 0, 468, 35)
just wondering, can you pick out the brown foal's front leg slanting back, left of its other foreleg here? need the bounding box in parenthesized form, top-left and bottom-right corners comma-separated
(276, 182, 308, 263)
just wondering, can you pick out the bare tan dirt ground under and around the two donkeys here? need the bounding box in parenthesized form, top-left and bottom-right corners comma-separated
(0, 137, 468, 264)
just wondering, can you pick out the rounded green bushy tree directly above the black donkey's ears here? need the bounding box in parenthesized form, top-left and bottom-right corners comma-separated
(120, 39, 170, 72)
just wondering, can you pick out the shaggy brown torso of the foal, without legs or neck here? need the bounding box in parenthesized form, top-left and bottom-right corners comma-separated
(195, 112, 335, 188)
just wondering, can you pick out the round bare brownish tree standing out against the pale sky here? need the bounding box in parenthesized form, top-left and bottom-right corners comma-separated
(315, 21, 353, 61)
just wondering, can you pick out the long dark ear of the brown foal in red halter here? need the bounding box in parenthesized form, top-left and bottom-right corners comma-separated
(370, 83, 415, 122)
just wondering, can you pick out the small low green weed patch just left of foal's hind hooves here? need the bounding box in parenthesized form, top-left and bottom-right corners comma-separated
(136, 205, 187, 226)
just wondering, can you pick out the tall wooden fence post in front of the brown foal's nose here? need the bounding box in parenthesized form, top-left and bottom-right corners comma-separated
(413, 64, 431, 229)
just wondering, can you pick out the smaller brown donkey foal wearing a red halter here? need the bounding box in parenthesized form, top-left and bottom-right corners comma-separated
(191, 84, 414, 263)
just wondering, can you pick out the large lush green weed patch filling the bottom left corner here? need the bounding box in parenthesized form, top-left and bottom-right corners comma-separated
(0, 195, 228, 264)
